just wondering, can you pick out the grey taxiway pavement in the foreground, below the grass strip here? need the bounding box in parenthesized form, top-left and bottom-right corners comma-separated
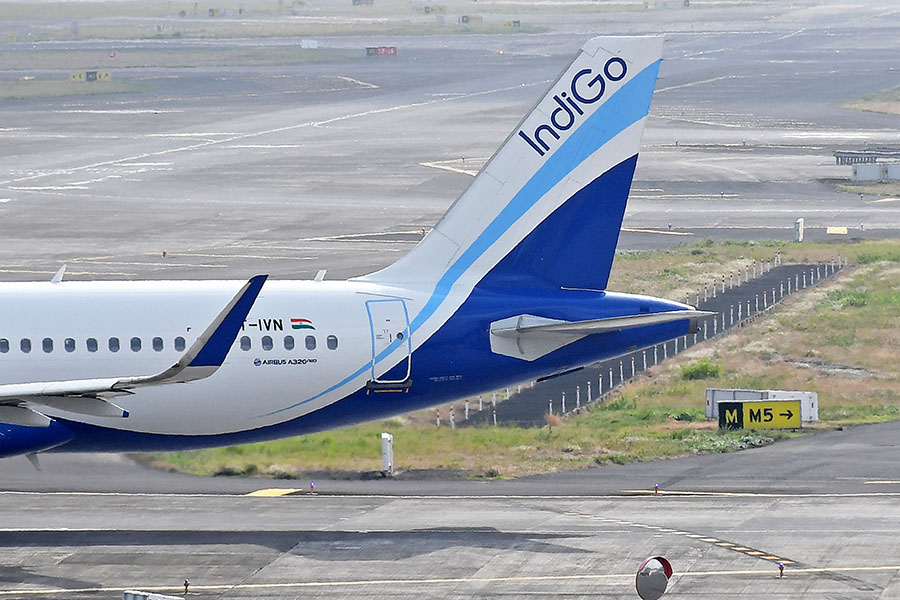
(0, 423, 900, 598)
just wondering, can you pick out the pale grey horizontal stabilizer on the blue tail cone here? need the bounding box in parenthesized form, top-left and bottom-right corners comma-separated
(491, 309, 714, 361)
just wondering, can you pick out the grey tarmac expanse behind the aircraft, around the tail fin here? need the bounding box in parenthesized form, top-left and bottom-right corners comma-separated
(0, 2, 900, 280)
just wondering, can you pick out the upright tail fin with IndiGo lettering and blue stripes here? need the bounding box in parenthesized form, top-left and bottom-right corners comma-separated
(362, 37, 663, 312)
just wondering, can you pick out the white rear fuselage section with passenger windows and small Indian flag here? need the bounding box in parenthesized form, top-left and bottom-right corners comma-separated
(0, 281, 426, 435)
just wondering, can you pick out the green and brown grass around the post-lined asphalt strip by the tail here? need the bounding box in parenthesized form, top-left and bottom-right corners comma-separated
(144, 240, 900, 479)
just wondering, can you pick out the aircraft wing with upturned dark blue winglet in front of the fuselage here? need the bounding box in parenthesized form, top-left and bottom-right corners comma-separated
(0, 275, 268, 427)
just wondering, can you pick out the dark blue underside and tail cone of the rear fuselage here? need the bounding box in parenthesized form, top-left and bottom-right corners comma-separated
(52, 158, 688, 452)
